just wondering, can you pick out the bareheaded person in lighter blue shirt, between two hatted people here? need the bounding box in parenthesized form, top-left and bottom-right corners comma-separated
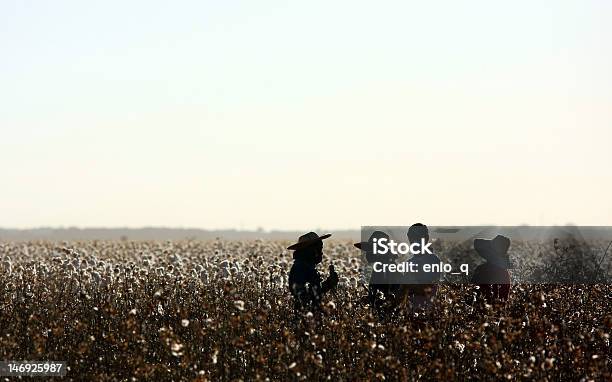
(400, 223, 441, 310)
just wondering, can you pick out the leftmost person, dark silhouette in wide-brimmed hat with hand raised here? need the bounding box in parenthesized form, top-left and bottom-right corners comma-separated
(287, 232, 338, 309)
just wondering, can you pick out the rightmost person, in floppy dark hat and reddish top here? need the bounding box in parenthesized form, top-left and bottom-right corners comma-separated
(472, 235, 512, 304)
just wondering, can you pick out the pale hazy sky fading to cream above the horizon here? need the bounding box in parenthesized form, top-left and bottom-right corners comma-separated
(0, 0, 612, 229)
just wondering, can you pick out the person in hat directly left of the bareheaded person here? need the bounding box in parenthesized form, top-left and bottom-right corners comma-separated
(353, 231, 399, 315)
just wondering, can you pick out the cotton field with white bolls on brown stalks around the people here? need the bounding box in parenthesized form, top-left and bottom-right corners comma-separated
(0, 240, 612, 381)
